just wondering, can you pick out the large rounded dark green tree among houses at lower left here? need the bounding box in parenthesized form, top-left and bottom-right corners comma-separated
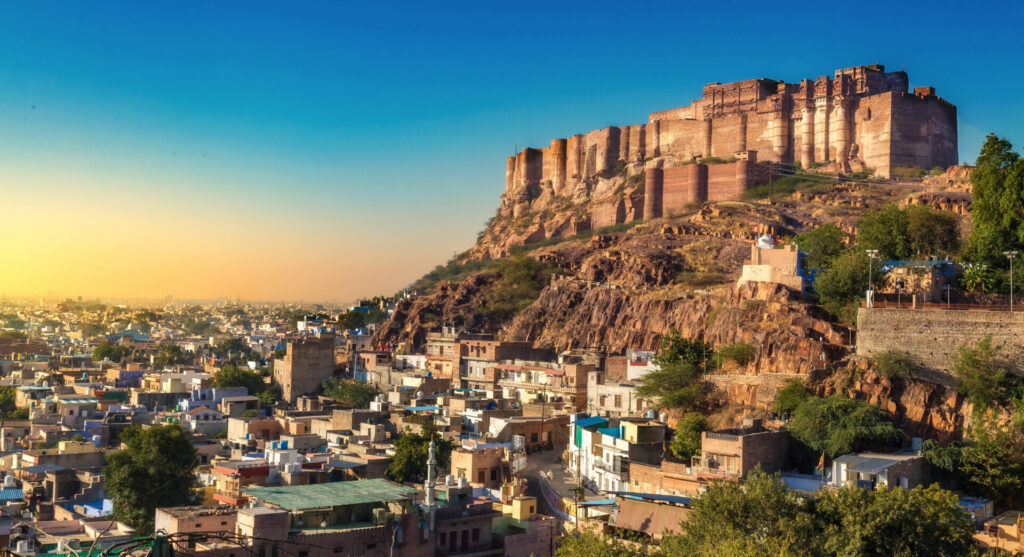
(103, 425, 199, 534)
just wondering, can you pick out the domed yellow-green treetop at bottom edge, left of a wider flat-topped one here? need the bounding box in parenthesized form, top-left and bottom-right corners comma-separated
(662, 471, 815, 557)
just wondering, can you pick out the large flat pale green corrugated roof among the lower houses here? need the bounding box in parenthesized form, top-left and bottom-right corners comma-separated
(242, 479, 419, 511)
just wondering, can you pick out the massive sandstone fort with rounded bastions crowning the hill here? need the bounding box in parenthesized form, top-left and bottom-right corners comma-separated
(502, 65, 957, 235)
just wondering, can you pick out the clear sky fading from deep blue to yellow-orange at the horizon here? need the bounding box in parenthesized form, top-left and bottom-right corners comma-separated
(0, 1, 1024, 301)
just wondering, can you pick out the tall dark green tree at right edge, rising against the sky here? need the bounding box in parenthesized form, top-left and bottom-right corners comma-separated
(965, 134, 1024, 268)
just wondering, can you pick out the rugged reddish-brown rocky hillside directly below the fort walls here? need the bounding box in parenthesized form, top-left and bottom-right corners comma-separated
(375, 166, 970, 438)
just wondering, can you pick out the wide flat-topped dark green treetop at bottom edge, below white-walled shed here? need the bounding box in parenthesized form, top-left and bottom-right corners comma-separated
(815, 484, 975, 557)
